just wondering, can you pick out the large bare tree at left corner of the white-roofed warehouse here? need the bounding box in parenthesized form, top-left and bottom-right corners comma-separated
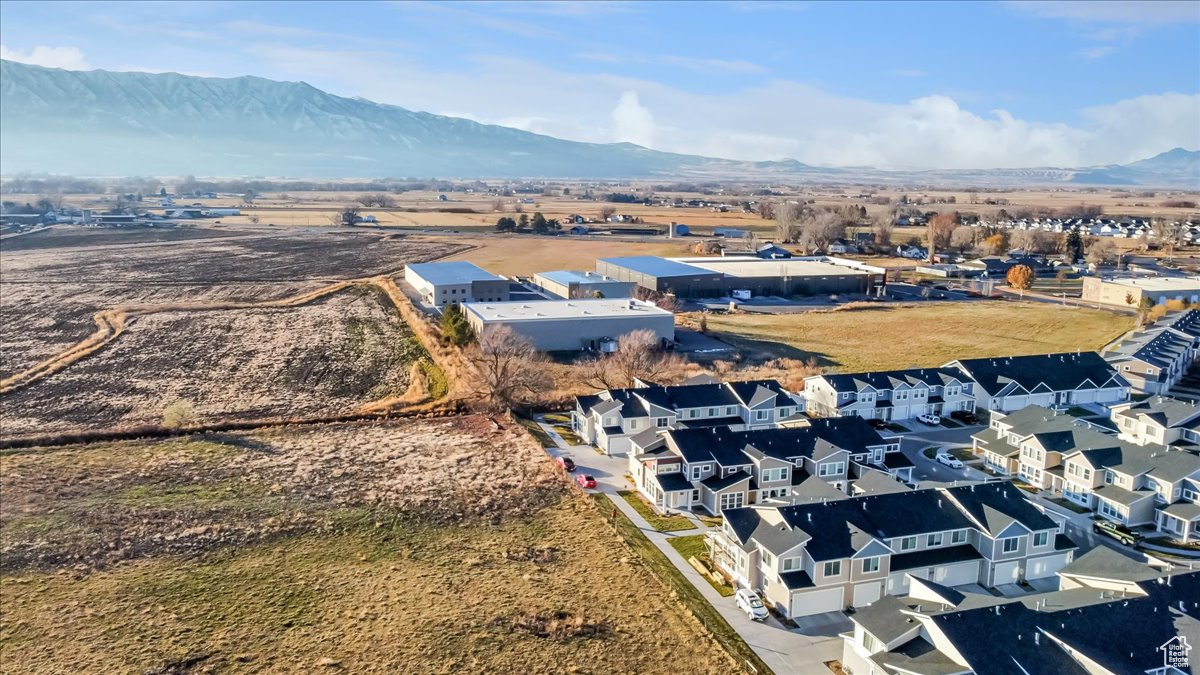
(467, 325, 550, 410)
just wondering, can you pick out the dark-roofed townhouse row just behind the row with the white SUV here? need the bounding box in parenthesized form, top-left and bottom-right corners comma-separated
(629, 418, 912, 515)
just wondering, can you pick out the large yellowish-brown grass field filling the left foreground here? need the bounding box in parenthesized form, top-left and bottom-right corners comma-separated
(0, 417, 734, 673)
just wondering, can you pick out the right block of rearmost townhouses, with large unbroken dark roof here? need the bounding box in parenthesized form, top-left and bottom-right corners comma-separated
(946, 352, 1129, 412)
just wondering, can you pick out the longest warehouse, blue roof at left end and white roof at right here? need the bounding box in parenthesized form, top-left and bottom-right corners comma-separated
(596, 256, 876, 298)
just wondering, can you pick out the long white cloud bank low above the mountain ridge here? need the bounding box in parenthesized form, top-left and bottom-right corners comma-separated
(241, 47, 1200, 168)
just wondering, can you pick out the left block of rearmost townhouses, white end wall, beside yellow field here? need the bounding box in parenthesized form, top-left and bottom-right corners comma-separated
(804, 368, 976, 420)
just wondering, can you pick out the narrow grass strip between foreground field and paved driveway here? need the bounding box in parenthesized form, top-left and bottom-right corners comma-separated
(593, 494, 770, 673)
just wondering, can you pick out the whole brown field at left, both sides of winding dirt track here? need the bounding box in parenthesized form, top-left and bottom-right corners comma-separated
(0, 228, 463, 425)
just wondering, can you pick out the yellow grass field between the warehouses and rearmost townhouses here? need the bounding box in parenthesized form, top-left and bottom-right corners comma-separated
(685, 300, 1133, 372)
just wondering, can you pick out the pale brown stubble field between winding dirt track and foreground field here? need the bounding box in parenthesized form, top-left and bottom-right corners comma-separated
(0, 287, 427, 436)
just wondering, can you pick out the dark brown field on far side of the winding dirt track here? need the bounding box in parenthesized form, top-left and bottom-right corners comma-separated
(0, 228, 461, 391)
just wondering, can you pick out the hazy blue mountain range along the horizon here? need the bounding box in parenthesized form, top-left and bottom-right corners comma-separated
(0, 61, 1200, 190)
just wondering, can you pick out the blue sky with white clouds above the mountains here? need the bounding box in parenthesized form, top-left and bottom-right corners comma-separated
(0, 0, 1200, 169)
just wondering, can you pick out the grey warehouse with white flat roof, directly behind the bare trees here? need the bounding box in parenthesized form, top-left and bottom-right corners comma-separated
(462, 299, 674, 352)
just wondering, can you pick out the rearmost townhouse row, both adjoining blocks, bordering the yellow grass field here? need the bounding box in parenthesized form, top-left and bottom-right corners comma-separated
(804, 352, 1130, 420)
